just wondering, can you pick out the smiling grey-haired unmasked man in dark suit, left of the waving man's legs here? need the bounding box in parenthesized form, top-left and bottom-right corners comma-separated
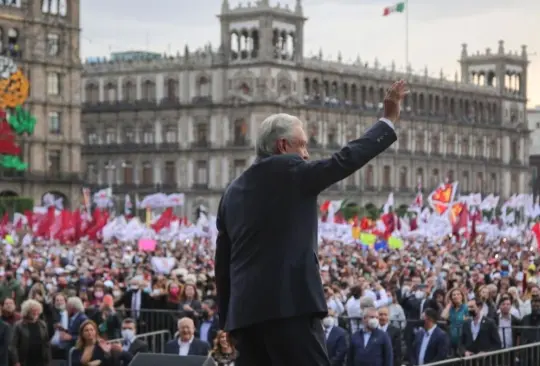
(165, 318, 210, 356)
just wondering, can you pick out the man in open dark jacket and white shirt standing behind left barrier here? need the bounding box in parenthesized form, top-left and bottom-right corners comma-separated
(114, 279, 152, 332)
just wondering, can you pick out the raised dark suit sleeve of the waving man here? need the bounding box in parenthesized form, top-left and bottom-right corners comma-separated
(291, 120, 397, 195)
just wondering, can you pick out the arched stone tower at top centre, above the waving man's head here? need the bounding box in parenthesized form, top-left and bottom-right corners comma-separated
(218, 0, 307, 64)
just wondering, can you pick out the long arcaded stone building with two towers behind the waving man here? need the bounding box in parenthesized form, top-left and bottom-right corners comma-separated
(82, 0, 529, 217)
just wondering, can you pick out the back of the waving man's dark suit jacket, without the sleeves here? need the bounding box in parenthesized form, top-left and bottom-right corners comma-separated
(218, 155, 327, 329)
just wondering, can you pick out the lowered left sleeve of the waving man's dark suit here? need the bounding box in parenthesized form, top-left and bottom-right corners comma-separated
(214, 198, 231, 329)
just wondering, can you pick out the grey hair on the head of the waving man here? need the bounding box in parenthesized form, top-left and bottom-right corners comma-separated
(255, 113, 303, 158)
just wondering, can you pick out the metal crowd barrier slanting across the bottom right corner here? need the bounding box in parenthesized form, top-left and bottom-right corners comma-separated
(426, 342, 540, 366)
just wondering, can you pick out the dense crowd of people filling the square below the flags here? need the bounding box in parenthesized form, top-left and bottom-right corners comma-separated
(0, 232, 540, 366)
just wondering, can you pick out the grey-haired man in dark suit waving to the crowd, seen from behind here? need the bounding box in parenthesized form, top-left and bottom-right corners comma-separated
(215, 81, 406, 366)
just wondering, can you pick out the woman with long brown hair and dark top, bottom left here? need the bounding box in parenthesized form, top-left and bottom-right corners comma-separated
(71, 320, 115, 366)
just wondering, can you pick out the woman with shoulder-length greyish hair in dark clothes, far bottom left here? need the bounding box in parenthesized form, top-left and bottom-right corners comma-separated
(10, 299, 51, 366)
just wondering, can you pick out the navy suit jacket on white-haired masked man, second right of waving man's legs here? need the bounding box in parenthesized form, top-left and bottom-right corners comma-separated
(347, 329, 394, 366)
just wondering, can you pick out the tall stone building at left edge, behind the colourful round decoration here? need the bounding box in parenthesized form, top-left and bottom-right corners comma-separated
(0, 0, 82, 206)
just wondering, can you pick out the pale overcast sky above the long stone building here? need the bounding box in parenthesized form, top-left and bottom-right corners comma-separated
(81, 0, 540, 107)
